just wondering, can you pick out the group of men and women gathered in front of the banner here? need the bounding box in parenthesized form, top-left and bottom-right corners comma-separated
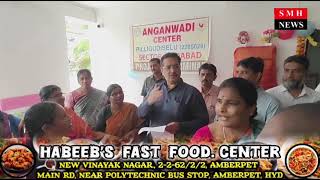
(0, 53, 320, 148)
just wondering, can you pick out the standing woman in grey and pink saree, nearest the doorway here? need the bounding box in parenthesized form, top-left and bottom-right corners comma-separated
(65, 69, 105, 129)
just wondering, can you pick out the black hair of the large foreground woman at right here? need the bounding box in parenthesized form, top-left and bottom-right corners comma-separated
(219, 77, 258, 118)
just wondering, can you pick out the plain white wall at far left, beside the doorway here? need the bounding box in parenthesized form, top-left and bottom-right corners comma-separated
(0, 1, 96, 99)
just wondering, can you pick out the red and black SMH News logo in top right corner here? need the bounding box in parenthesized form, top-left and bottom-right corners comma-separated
(274, 8, 308, 30)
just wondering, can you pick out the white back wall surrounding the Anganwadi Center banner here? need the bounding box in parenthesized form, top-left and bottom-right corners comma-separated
(92, 1, 320, 105)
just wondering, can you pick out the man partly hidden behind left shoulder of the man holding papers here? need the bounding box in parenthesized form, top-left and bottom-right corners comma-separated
(141, 58, 164, 97)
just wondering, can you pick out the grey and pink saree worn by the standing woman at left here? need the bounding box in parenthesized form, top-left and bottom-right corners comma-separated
(66, 88, 105, 128)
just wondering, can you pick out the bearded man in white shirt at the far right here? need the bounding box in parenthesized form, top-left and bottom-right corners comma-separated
(267, 55, 320, 108)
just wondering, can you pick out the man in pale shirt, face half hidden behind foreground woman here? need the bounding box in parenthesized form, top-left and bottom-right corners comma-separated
(236, 57, 280, 124)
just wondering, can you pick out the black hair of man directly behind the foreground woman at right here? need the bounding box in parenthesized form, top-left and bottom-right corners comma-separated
(237, 57, 264, 73)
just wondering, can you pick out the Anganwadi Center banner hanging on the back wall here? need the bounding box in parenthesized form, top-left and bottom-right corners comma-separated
(132, 17, 210, 71)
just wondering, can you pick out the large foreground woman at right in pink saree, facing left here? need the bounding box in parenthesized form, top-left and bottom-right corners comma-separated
(191, 78, 264, 144)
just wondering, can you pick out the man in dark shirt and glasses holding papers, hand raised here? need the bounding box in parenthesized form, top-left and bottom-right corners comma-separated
(138, 53, 209, 136)
